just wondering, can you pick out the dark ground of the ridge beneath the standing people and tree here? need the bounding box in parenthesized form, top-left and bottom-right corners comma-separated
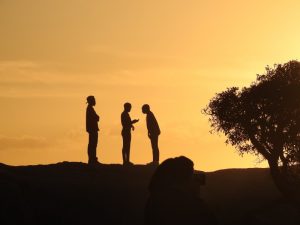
(0, 162, 300, 225)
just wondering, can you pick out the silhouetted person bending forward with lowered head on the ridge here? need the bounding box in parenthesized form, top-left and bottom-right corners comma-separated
(142, 104, 160, 165)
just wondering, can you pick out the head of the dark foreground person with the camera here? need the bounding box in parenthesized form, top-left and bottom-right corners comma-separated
(149, 156, 200, 194)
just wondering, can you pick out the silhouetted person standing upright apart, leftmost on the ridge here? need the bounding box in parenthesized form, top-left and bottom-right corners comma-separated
(86, 96, 100, 164)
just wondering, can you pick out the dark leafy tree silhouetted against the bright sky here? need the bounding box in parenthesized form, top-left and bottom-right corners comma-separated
(203, 61, 300, 200)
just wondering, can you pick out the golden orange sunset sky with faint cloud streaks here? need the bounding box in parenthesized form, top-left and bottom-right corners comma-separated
(0, 0, 300, 171)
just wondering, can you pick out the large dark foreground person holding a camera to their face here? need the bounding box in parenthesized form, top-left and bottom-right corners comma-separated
(145, 156, 217, 225)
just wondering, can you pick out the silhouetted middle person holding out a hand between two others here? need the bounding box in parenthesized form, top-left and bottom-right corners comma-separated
(121, 102, 139, 165)
